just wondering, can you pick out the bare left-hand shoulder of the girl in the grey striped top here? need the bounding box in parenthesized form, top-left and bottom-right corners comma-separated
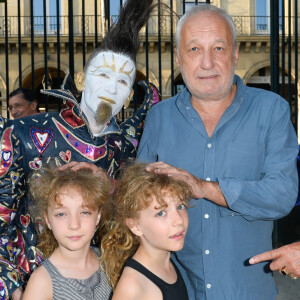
(22, 266, 52, 300)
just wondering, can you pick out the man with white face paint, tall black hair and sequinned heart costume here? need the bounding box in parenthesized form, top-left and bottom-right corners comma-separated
(0, 0, 158, 299)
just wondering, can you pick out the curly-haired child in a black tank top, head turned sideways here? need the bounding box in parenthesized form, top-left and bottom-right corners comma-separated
(101, 164, 191, 300)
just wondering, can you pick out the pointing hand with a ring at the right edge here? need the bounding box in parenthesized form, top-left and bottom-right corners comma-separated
(249, 242, 300, 277)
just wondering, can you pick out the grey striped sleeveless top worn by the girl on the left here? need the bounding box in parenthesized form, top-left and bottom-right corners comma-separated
(42, 247, 112, 300)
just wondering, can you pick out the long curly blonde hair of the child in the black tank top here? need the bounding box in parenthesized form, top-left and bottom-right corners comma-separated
(100, 163, 191, 289)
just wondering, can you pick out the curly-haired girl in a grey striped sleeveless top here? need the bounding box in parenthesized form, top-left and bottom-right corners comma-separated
(22, 169, 111, 300)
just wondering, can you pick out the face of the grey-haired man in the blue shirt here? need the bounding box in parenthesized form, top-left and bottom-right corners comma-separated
(176, 12, 238, 100)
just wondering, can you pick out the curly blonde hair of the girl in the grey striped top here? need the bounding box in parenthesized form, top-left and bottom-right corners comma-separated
(28, 168, 110, 258)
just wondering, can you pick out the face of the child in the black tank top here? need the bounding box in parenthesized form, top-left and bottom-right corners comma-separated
(127, 193, 189, 251)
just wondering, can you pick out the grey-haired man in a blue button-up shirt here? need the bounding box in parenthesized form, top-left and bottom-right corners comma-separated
(138, 5, 298, 300)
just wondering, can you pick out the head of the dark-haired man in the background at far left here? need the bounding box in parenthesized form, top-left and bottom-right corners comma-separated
(8, 88, 39, 119)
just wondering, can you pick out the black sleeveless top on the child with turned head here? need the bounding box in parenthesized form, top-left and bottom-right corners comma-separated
(125, 258, 189, 300)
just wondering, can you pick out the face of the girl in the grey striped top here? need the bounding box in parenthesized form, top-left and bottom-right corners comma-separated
(45, 186, 101, 251)
